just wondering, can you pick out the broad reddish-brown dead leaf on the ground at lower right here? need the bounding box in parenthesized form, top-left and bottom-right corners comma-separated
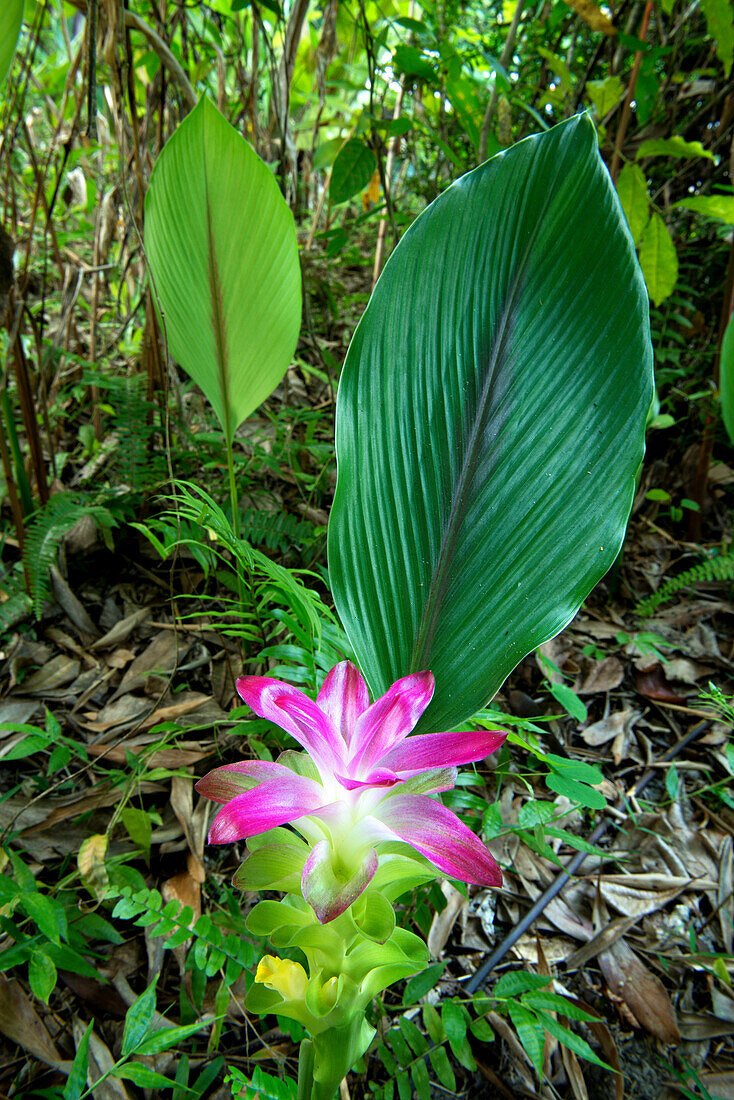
(599, 939, 680, 1044)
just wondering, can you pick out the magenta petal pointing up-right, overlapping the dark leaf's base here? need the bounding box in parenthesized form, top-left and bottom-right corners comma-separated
(349, 672, 435, 779)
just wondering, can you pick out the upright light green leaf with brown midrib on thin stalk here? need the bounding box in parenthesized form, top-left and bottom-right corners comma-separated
(145, 98, 300, 440)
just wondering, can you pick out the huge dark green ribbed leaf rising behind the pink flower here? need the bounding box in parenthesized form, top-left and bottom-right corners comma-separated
(329, 116, 653, 732)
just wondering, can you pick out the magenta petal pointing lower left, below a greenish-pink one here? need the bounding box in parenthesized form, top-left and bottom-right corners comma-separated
(209, 768, 325, 844)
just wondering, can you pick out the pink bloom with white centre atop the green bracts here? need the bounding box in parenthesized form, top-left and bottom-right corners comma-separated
(197, 661, 507, 923)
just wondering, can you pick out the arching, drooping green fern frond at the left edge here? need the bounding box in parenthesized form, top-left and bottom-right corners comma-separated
(23, 493, 117, 619)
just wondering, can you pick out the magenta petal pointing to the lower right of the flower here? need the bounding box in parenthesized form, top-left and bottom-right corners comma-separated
(373, 794, 502, 887)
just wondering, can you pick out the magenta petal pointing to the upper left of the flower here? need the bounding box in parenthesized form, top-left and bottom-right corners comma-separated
(237, 677, 346, 774)
